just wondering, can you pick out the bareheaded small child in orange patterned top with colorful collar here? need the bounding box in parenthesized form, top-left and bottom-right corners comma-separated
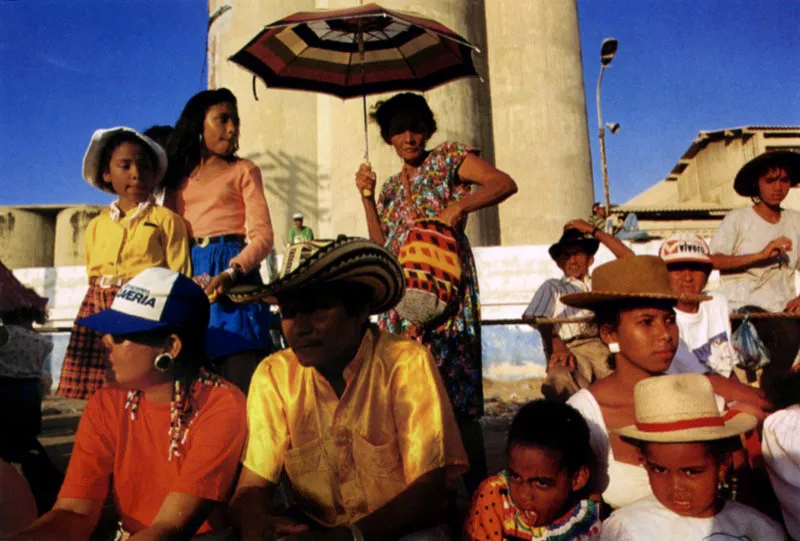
(464, 400, 600, 541)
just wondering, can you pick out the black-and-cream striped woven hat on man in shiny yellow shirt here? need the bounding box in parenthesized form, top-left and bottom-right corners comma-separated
(227, 236, 405, 314)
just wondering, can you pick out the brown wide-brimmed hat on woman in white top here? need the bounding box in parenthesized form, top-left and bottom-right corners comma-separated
(561, 255, 711, 310)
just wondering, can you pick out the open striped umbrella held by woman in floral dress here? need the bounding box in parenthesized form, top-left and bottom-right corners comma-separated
(230, 4, 478, 160)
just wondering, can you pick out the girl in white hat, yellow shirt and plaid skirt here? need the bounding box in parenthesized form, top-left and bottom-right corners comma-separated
(56, 127, 191, 398)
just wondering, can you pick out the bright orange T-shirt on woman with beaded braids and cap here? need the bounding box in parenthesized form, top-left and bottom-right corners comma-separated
(58, 384, 246, 533)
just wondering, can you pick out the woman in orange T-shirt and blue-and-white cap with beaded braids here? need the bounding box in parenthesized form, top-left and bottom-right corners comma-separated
(12, 268, 246, 540)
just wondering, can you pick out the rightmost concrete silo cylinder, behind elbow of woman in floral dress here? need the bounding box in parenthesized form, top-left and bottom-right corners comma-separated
(486, 0, 594, 245)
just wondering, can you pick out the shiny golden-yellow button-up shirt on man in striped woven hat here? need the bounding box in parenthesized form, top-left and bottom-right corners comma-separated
(244, 327, 467, 526)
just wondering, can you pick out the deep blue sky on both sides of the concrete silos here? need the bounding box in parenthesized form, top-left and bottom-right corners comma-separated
(0, 0, 800, 205)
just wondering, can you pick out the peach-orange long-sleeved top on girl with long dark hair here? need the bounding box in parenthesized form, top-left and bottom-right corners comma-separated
(170, 160, 273, 272)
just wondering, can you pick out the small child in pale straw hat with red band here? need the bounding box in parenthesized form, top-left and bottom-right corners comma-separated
(600, 374, 786, 541)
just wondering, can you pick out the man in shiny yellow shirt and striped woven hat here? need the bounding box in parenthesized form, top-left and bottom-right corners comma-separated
(230, 237, 468, 541)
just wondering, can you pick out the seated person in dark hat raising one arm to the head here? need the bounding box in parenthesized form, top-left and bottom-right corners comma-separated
(522, 220, 633, 400)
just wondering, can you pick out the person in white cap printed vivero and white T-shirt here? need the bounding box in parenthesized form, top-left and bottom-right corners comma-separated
(658, 232, 770, 410)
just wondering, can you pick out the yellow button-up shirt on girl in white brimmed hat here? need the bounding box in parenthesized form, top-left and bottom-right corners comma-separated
(84, 201, 192, 280)
